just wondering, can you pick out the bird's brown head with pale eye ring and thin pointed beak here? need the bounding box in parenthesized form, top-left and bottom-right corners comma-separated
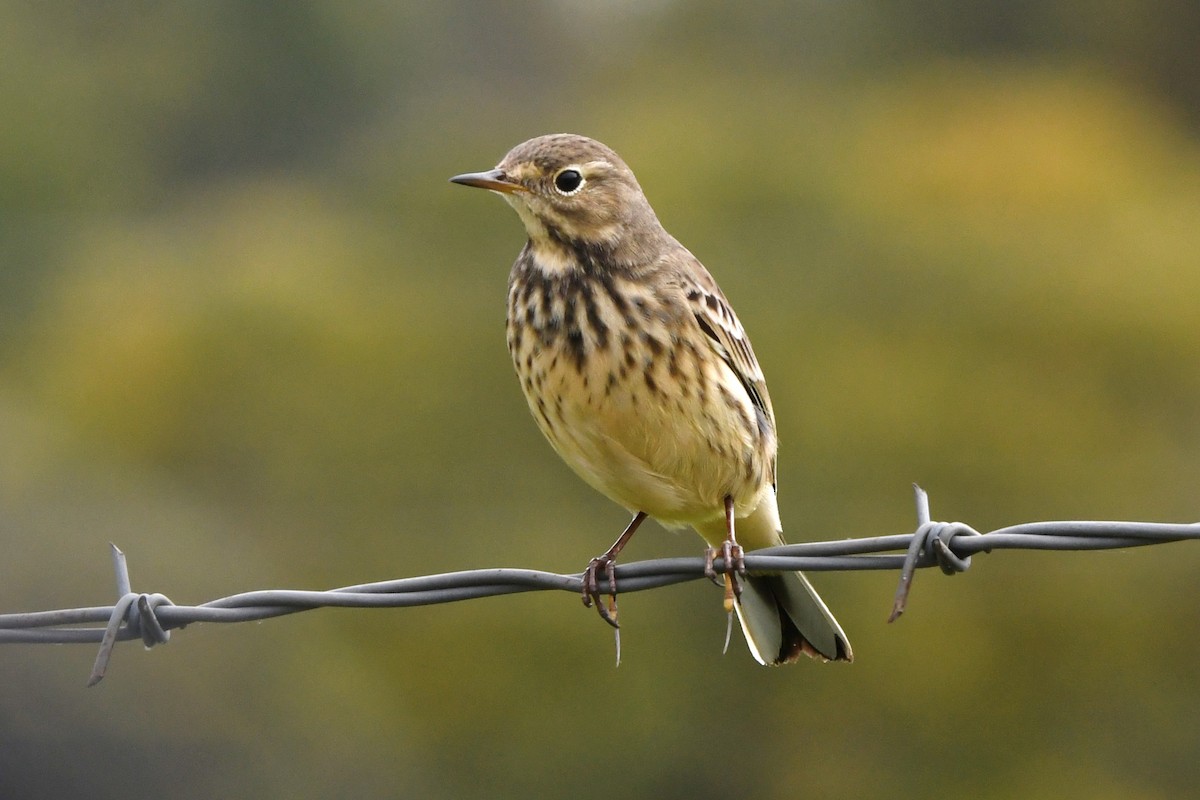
(450, 133, 666, 262)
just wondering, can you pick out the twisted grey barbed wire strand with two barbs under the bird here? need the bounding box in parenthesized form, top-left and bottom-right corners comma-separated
(7, 486, 1200, 686)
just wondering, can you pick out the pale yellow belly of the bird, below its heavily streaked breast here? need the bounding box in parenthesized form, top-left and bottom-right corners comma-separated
(515, 328, 768, 525)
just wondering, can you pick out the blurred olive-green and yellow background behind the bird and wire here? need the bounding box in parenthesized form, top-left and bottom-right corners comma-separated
(0, 0, 1200, 800)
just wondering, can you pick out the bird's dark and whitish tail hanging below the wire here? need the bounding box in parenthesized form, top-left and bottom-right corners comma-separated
(736, 572, 854, 664)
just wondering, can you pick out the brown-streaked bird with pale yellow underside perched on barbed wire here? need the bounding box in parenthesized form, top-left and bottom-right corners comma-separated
(450, 133, 853, 664)
